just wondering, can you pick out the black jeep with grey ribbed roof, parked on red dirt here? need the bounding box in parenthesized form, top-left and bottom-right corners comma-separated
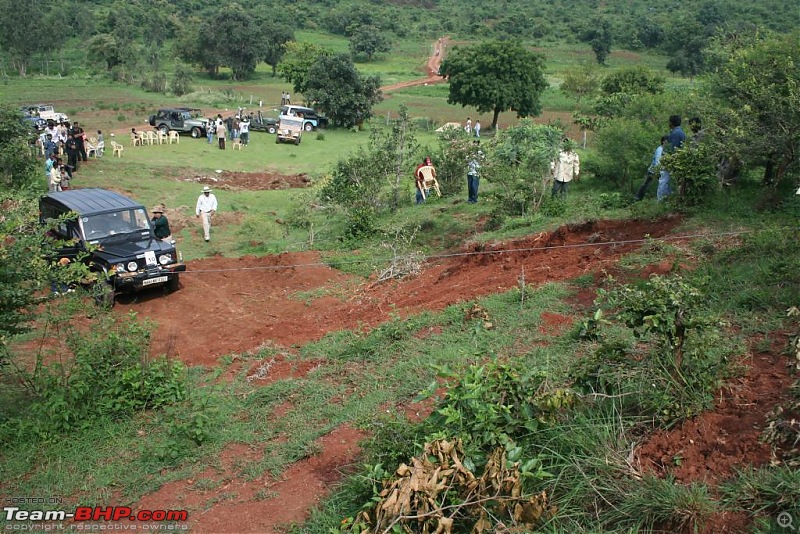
(39, 189, 186, 305)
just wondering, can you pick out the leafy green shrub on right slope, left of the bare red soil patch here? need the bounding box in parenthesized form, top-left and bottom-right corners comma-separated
(570, 275, 737, 424)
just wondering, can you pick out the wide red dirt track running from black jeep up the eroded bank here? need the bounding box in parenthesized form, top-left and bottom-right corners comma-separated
(116, 219, 678, 365)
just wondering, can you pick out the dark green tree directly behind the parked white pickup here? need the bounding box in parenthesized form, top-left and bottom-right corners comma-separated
(303, 54, 382, 127)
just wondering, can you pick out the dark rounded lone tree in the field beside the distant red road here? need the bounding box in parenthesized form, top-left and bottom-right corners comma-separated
(441, 41, 548, 128)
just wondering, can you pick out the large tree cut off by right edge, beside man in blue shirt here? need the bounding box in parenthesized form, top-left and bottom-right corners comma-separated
(706, 32, 800, 191)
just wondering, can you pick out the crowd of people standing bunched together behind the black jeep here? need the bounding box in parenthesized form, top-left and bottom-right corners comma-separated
(36, 120, 104, 192)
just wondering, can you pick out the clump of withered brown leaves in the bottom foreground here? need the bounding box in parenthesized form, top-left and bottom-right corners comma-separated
(351, 439, 556, 534)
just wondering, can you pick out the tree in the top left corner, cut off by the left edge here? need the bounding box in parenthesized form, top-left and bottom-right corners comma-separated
(0, 0, 54, 77)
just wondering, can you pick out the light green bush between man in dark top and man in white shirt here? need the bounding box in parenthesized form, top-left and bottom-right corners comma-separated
(483, 119, 564, 215)
